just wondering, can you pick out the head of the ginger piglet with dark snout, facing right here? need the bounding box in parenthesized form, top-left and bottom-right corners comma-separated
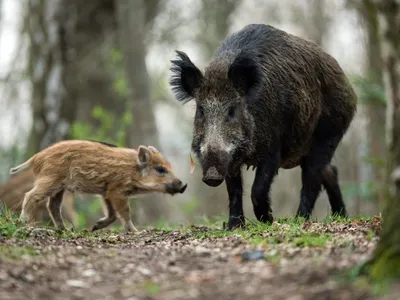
(137, 146, 187, 195)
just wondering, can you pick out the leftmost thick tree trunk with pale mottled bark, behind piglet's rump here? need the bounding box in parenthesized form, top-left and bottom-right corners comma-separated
(26, 0, 76, 156)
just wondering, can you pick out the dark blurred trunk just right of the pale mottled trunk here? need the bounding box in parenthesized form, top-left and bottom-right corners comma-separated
(70, 0, 126, 128)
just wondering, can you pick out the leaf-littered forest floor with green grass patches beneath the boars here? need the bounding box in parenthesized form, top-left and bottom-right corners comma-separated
(0, 217, 400, 300)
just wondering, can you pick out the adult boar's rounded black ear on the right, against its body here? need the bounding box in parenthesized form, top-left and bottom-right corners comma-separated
(228, 52, 261, 94)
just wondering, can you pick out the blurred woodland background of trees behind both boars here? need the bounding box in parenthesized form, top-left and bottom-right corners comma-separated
(0, 0, 386, 226)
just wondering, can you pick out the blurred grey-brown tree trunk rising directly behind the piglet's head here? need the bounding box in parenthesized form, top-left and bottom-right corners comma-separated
(116, 0, 172, 223)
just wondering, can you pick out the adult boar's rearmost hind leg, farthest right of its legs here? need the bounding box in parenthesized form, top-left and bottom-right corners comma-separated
(322, 165, 347, 217)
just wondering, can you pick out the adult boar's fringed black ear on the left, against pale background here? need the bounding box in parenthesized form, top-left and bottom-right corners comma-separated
(169, 51, 203, 103)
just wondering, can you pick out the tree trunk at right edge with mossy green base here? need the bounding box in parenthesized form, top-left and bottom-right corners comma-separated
(368, 0, 400, 280)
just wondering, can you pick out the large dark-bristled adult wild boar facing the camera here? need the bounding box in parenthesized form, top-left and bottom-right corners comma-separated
(170, 24, 357, 229)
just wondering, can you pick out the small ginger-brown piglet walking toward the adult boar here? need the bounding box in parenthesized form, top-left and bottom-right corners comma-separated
(10, 140, 187, 232)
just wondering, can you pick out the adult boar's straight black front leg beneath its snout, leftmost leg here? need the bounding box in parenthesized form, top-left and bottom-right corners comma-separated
(225, 171, 245, 230)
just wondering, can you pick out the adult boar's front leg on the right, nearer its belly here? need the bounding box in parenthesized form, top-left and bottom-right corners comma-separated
(251, 152, 280, 222)
